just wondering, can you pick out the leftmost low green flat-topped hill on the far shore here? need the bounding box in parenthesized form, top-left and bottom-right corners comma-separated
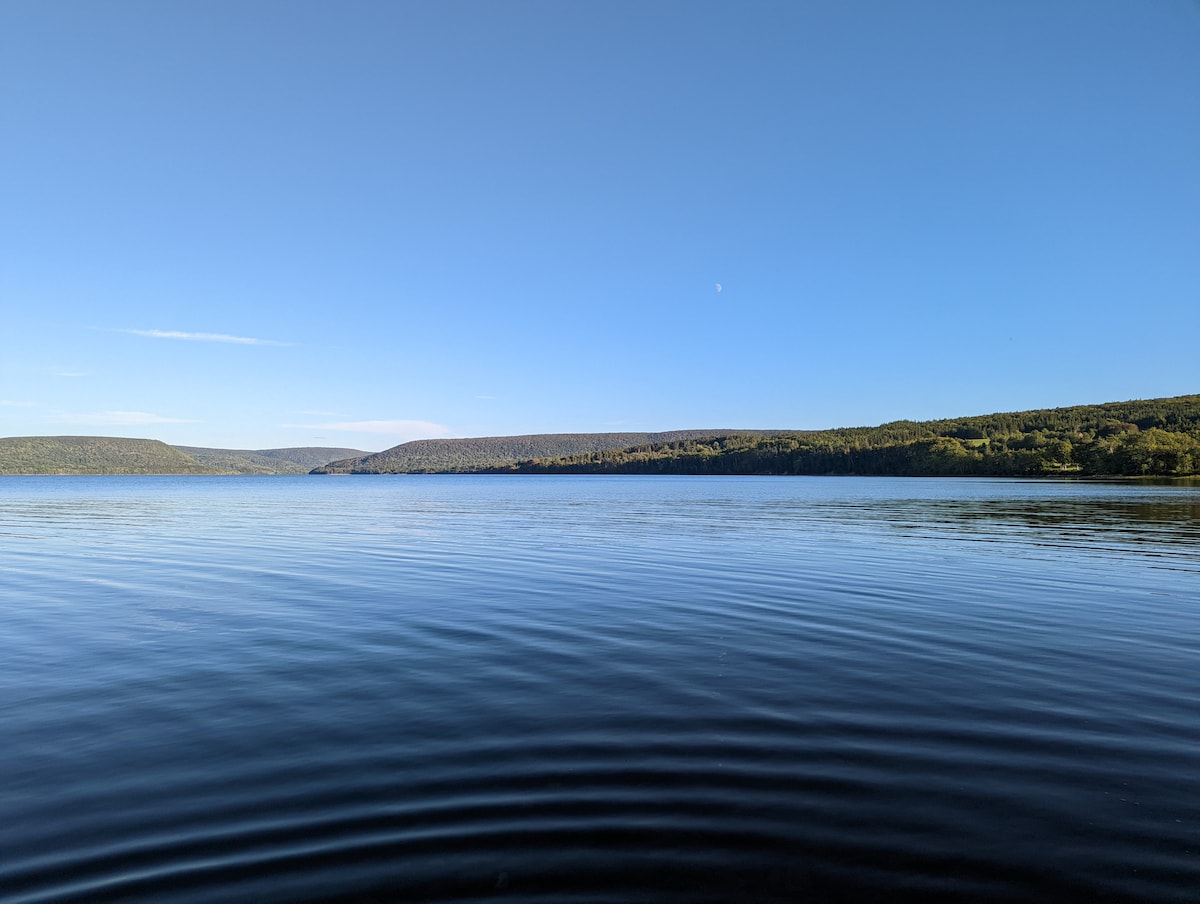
(0, 436, 215, 474)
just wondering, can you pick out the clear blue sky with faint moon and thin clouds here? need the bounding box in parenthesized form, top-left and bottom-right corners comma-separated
(0, 0, 1200, 450)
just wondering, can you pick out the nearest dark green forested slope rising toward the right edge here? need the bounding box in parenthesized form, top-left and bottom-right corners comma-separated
(493, 395, 1200, 477)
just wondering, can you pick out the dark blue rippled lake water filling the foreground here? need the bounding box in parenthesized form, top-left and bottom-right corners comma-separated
(0, 477, 1200, 903)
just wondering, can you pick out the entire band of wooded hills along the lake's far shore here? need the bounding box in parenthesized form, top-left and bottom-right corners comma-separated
(9, 395, 1200, 478)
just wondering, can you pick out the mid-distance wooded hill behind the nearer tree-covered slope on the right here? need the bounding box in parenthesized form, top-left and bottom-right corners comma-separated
(312, 430, 779, 474)
